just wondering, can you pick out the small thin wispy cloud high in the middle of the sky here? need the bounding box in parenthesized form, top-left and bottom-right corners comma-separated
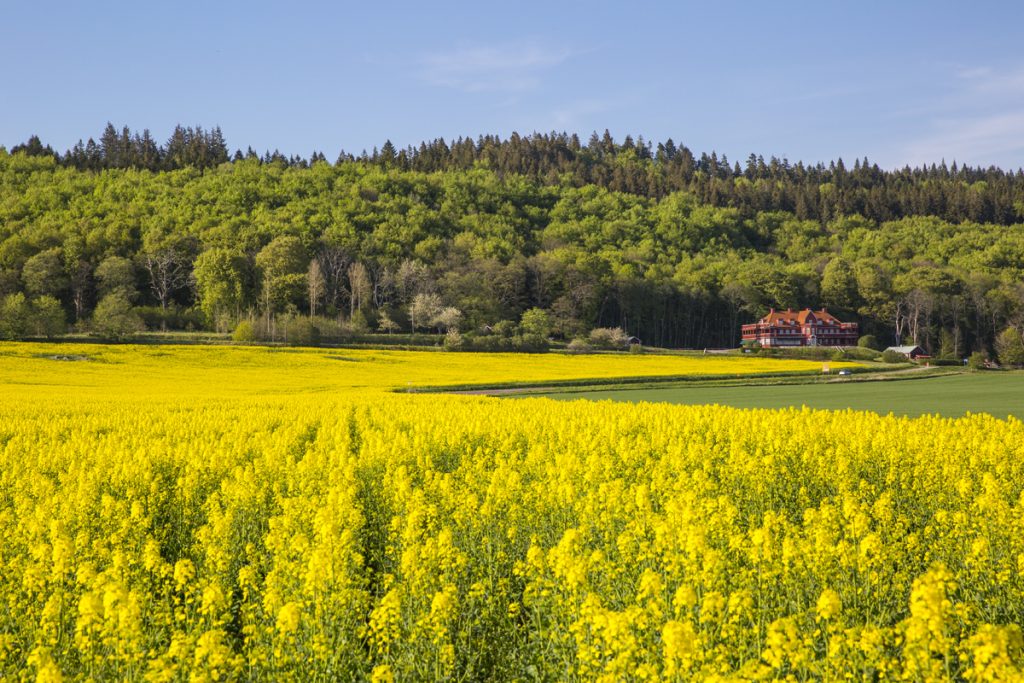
(420, 43, 573, 93)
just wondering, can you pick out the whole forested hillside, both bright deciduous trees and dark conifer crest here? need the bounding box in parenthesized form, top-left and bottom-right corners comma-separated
(0, 126, 1024, 356)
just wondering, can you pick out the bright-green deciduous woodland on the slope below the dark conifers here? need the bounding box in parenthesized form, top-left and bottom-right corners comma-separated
(0, 147, 1024, 356)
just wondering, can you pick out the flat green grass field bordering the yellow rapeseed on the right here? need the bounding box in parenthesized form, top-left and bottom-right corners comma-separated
(544, 372, 1024, 419)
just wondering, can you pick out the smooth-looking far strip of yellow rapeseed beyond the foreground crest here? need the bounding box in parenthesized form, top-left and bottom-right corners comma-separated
(0, 343, 839, 401)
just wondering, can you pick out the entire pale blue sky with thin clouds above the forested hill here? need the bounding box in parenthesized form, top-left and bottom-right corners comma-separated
(0, 0, 1024, 169)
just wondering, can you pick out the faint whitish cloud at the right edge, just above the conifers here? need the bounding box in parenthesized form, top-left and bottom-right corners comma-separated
(900, 66, 1024, 168)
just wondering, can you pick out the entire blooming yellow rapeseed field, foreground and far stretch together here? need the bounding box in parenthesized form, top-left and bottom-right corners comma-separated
(0, 345, 1024, 681)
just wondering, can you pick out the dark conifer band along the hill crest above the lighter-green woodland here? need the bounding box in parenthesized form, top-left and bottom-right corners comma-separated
(11, 124, 1024, 225)
